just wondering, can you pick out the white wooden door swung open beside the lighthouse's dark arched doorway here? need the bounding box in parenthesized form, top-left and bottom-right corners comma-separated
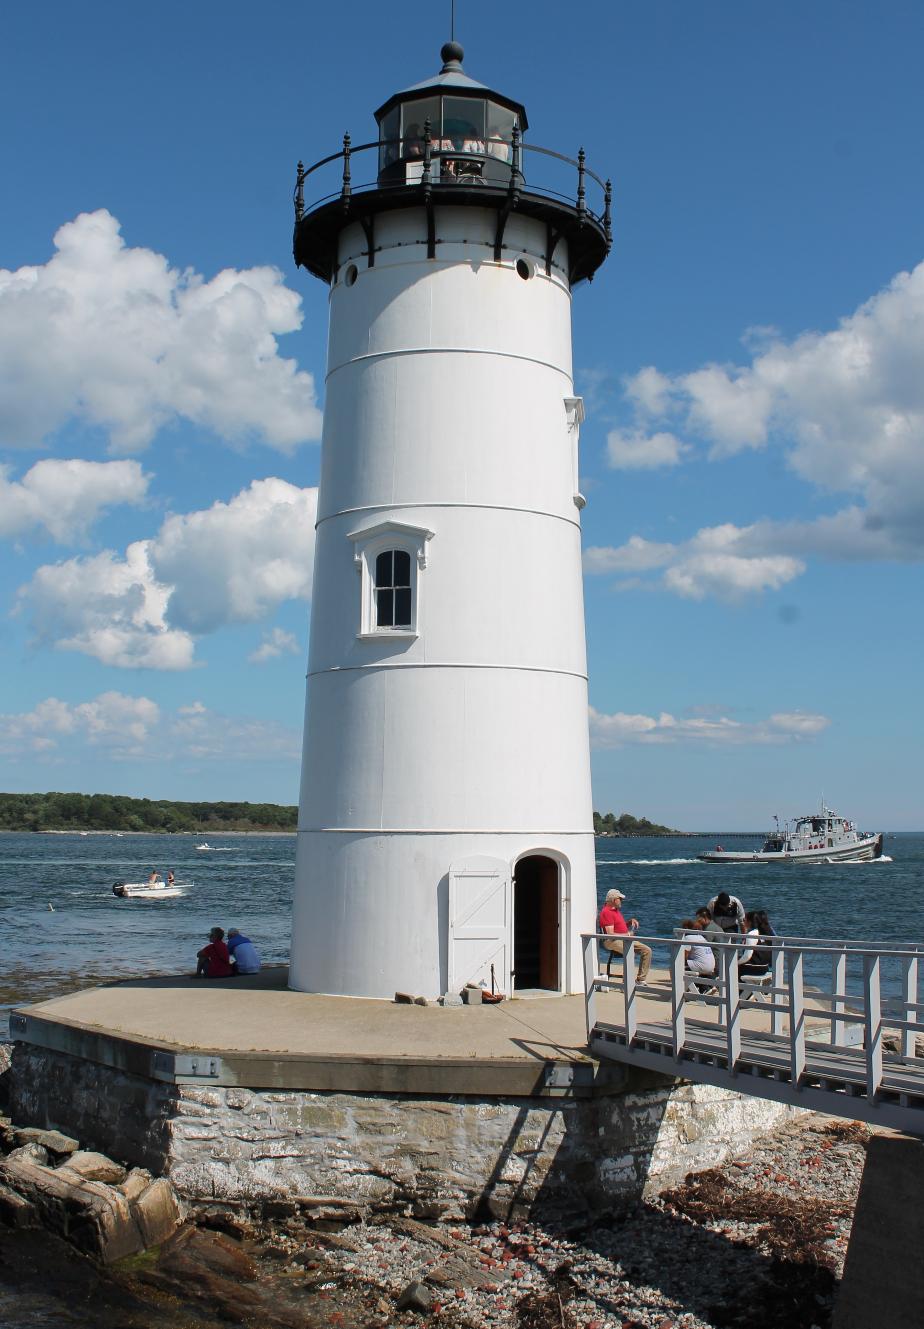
(448, 855, 511, 995)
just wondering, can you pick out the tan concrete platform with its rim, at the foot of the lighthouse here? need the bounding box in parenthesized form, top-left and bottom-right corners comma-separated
(11, 966, 635, 1096)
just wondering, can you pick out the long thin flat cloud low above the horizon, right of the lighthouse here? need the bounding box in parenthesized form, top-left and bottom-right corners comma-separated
(590, 706, 831, 748)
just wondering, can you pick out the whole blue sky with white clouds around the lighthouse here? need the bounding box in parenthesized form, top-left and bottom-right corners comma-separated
(0, 0, 924, 829)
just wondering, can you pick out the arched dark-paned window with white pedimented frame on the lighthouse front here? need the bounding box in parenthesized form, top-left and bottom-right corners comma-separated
(348, 521, 433, 637)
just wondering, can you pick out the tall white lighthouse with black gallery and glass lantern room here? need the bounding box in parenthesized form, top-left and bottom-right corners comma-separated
(290, 43, 610, 997)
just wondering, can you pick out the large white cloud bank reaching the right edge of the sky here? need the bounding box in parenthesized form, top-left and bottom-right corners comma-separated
(610, 263, 924, 566)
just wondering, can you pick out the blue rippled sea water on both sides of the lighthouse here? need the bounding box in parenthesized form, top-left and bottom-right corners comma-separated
(0, 833, 924, 1031)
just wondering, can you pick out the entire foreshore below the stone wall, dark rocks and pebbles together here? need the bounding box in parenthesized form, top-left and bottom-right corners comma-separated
(0, 1114, 868, 1329)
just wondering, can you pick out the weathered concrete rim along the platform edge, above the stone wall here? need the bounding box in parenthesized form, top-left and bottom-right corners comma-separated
(11, 1006, 628, 1098)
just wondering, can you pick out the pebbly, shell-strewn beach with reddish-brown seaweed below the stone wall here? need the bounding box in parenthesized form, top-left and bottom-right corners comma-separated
(224, 1114, 868, 1329)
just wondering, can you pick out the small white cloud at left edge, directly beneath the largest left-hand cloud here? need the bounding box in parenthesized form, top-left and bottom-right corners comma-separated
(0, 457, 150, 544)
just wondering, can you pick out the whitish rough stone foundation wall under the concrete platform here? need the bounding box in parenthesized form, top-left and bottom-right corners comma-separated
(11, 1046, 795, 1219)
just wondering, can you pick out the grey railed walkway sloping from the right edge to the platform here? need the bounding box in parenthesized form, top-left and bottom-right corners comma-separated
(582, 933, 924, 1136)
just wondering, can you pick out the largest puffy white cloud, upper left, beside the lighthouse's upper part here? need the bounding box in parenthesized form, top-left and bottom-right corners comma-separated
(0, 209, 320, 452)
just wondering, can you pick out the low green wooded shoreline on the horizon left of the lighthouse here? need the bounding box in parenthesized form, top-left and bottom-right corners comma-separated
(0, 793, 298, 832)
